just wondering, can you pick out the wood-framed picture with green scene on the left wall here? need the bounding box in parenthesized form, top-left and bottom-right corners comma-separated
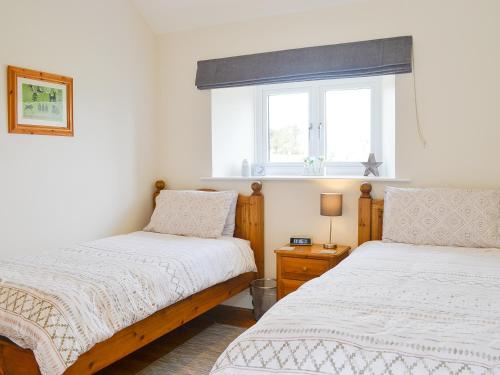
(7, 66, 73, 137)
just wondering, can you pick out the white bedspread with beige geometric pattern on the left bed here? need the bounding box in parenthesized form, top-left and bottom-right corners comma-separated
(0, 232, 256, 375)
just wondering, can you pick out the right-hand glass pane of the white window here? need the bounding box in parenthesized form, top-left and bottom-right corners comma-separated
(325, 89, 371, 161)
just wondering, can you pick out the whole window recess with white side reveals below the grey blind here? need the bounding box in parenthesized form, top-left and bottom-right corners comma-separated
(212, 75, 395, 177)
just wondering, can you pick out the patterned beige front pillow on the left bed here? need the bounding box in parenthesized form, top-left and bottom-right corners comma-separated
(144, 190, 237, 238)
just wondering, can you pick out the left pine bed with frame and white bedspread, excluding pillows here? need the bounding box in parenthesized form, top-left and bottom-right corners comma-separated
(0, 181, 264, 375)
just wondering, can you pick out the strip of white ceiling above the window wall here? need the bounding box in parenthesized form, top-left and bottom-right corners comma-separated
(132, 0, 355, 34)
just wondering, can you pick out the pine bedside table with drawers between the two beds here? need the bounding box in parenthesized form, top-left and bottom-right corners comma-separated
(274, 245, 351, 299)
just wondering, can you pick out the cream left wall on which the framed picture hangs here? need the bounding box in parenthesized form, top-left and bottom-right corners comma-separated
(0, 0, 157, 255)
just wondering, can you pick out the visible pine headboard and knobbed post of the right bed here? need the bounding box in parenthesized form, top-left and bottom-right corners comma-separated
(358, 182, 384, 246)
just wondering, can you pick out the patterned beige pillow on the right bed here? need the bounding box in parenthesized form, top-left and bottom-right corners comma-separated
(382, 187, 500, 248)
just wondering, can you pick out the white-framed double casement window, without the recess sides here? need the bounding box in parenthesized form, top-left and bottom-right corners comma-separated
(256, 77, 382, 175)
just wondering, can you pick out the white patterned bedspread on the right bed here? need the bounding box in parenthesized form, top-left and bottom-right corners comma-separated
(212, 242, 500, 375)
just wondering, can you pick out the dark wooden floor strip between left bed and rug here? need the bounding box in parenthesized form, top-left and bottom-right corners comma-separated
(97, 305, 255, 375)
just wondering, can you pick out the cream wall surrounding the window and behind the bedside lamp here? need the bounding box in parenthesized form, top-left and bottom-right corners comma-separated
(159, 0, 500, 276)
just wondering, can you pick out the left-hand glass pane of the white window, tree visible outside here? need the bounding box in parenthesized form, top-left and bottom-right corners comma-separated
(268, 93, 309, 162)
